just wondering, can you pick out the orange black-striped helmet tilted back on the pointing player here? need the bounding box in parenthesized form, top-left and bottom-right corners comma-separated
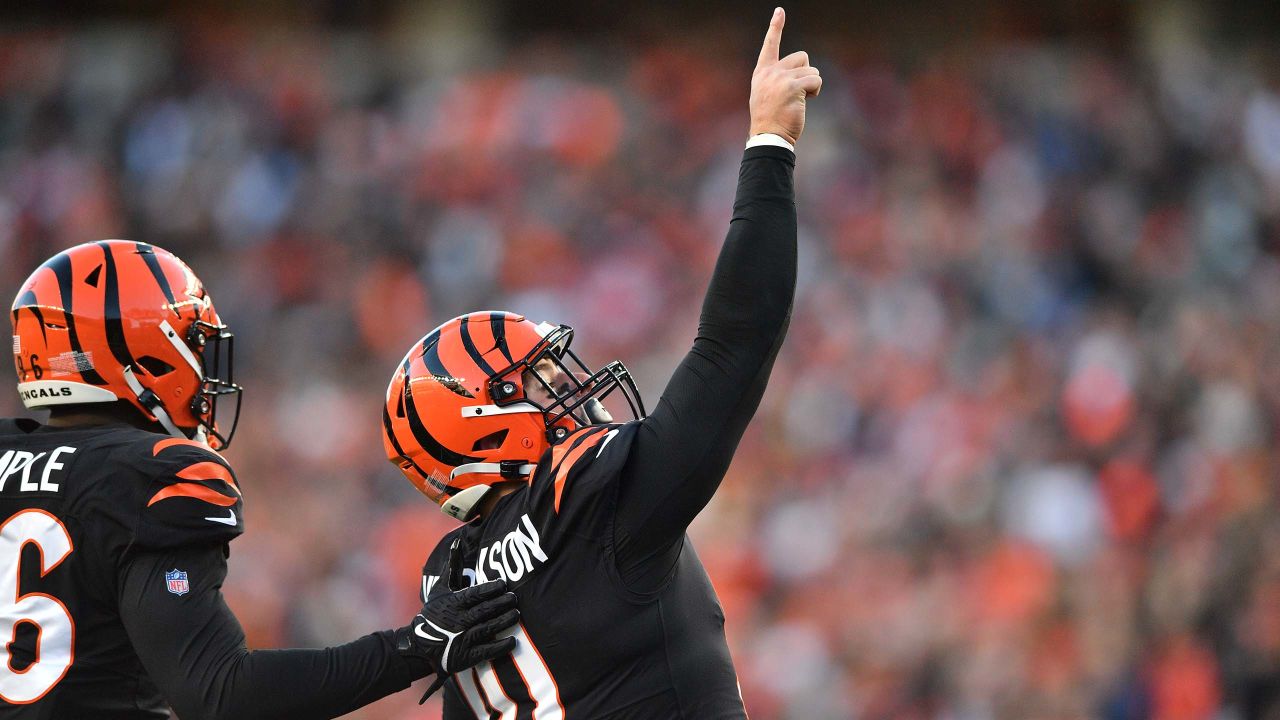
(383, 313, 644, 520)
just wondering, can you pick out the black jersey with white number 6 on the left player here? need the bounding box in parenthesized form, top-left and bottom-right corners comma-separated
(0, 419, 243, 720)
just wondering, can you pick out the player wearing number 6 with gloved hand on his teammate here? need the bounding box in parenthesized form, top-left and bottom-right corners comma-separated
(0, 240, 517, 720)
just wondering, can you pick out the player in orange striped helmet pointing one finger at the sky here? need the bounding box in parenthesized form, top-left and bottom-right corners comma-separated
(383, 9, 822, 720)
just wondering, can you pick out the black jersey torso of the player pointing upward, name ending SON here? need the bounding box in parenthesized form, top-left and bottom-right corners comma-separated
(422, 423, 746, 720)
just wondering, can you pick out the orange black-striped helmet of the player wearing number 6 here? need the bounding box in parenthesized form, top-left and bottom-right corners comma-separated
(12, 240, 241, 448)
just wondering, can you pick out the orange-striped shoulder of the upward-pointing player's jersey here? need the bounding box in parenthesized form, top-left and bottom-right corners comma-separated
(535, 421, 640, 514)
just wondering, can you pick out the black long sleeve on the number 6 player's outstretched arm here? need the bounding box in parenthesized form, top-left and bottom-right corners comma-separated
(120, 546, 422, 720)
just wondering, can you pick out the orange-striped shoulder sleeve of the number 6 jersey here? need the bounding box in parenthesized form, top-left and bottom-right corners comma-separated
(134, 437, 244, 547)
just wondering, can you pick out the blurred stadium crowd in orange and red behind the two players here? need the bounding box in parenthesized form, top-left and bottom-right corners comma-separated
(0, 0, 1280, 720)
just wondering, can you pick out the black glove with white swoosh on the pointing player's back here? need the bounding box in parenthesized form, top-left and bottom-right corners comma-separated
(396, 539, 520, 705)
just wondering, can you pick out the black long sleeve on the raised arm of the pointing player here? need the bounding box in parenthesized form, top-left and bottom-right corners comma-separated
(614, 146, 796, 591)
